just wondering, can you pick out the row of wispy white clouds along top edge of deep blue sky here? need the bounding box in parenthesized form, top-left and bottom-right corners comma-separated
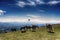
(17, 0, 60, 7)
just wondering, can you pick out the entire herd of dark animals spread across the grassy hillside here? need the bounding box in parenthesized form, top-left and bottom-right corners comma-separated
(0, 24, 54, 33)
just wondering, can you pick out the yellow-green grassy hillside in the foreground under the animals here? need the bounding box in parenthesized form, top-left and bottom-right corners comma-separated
(0, 25, 60, 40)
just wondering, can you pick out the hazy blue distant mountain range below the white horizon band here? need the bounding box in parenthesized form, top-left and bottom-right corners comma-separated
(0, 22, 45, 28)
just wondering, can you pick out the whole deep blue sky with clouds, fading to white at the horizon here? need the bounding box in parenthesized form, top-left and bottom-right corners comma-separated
(0, 0, 60, 23)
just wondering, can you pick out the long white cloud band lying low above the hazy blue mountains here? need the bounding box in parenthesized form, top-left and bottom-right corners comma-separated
(0, 14, 60, 24)
